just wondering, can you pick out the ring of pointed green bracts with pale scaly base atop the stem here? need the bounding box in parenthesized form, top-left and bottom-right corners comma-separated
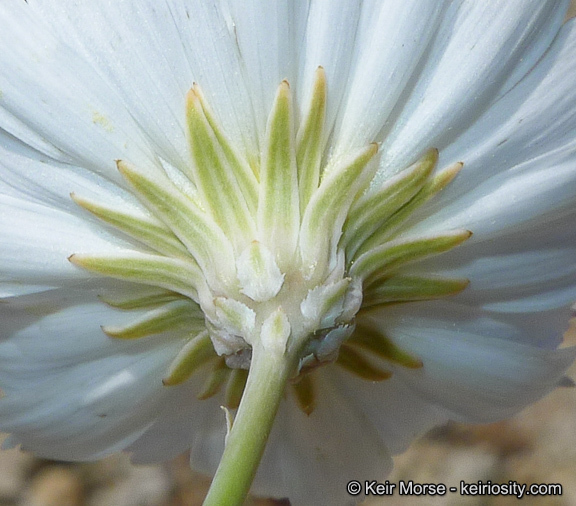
(70, 68, 471, 413)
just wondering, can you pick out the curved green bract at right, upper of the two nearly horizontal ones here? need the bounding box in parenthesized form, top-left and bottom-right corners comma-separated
(350, 230, 472, 289)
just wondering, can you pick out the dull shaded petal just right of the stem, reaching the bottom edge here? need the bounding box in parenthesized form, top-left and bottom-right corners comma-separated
(252, 371, 392, 506)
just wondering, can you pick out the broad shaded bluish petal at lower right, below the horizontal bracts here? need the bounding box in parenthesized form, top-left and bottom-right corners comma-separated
(366, 303, 576, 423)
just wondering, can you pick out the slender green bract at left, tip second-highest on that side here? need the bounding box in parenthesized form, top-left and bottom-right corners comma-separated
(70, 193, 189, 257)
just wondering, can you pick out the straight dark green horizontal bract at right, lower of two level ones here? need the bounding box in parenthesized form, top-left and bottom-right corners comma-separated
(362, 275, 470, 309)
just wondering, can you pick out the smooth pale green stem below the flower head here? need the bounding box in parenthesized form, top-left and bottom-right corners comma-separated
(204, 346, 294, 506)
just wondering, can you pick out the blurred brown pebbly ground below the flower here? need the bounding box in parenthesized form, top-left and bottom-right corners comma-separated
(0, 0, 576, 506)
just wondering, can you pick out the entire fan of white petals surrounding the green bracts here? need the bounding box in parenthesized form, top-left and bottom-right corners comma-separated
(0, 0, 576, 504)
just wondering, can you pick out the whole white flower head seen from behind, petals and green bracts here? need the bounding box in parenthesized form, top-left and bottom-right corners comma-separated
(0, 0, 576, 504)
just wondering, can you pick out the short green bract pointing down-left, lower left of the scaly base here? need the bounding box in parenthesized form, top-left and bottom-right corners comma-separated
(162, 331, 217, 386)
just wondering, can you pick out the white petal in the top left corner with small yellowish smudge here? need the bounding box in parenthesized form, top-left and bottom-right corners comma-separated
(0, 2, 153, 175)
